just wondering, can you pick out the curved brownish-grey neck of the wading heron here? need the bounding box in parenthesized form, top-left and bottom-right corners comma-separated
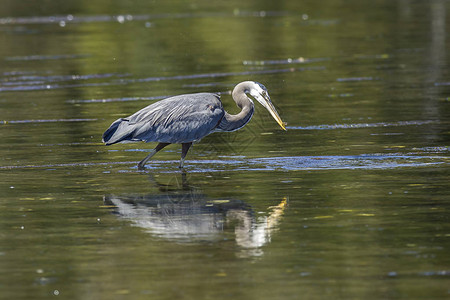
(217, 81, 255, 131)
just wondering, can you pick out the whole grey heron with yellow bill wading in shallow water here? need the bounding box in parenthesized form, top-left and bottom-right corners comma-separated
(103, 81, 286, 170)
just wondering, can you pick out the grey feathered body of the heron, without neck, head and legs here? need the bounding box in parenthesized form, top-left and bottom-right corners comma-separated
(103, 93, 224, 145)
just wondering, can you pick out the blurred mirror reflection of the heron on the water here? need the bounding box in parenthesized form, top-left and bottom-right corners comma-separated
(104, 173, 287, 257)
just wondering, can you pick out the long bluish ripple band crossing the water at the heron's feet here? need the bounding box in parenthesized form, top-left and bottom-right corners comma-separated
(0, 154, 450, 173)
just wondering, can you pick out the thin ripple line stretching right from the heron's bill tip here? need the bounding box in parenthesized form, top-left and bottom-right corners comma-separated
(286, 120, 440, 130)
